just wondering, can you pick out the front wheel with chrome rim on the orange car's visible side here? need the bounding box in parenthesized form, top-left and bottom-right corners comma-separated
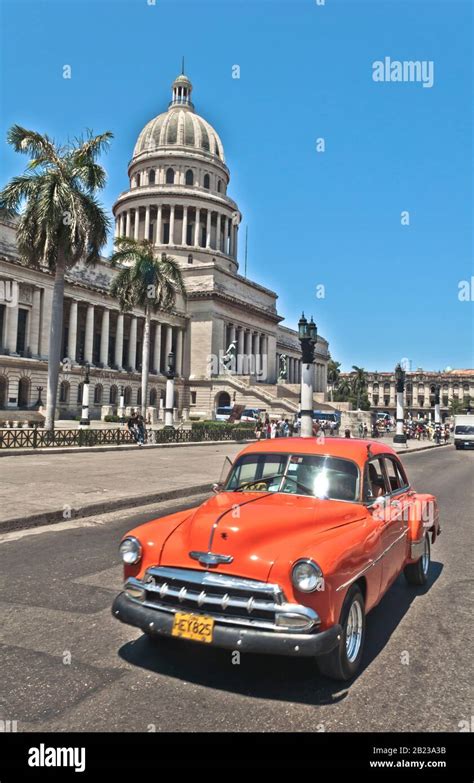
(318, 585, 365, 680)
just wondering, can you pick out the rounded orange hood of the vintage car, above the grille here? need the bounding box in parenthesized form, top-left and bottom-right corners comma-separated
(160, 492, 363, 581)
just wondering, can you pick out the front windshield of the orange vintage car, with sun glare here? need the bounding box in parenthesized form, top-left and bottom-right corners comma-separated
(224, 454, 359, 501)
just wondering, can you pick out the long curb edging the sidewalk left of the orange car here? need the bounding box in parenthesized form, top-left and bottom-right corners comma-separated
(0, 484, 212, 535)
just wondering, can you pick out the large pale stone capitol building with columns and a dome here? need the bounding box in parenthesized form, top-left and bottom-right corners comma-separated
(0, 74, 329, 420)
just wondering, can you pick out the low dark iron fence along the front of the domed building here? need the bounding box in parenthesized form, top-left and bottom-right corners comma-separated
(0, 426, 255, 449)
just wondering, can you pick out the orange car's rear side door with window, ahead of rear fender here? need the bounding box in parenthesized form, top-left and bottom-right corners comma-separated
(381, 454, 410, 589)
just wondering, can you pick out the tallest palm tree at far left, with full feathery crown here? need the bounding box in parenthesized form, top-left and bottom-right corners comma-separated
(0, 125, 113, 430)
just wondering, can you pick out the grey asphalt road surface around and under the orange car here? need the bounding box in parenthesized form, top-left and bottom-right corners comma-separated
(0, 448, 474, 731)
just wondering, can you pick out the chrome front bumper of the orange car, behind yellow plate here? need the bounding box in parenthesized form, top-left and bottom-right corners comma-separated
(112, 592, 342, 657)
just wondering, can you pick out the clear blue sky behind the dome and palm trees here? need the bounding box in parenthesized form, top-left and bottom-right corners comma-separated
(0, 0, 474, 371)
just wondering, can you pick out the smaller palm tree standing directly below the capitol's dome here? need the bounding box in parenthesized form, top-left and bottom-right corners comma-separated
(110, 237, 186, 418)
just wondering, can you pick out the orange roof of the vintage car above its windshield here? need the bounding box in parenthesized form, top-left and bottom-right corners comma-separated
(240, 437, 397, 463)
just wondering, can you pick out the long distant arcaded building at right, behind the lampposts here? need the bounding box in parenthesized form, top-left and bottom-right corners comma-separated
(341, 368, 474, 419)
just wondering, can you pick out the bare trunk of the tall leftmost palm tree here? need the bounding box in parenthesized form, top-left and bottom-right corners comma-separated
(44, 250, 66, 430)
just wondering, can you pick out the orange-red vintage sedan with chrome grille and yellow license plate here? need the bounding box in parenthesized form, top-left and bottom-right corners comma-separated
(112, 437, 440, 680)
